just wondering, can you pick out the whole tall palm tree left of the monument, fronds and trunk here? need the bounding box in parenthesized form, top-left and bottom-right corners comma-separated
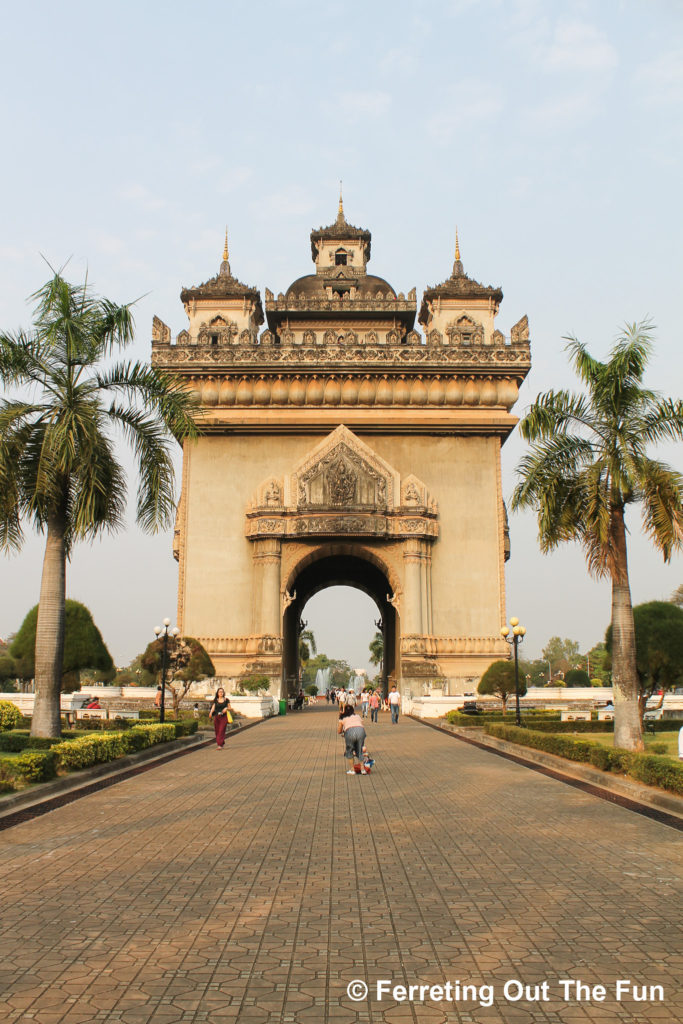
(0, 273, 198, 736)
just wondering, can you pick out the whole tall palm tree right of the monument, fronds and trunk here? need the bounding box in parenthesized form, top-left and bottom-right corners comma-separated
(512, 322, 683, 751)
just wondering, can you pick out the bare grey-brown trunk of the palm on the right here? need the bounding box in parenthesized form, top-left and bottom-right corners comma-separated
(612, 508, 645, 751)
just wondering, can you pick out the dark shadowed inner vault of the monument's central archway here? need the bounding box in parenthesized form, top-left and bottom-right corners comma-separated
(282, 545, 398, 697)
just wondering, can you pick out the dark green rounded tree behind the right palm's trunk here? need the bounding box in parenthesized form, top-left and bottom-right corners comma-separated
(605, 601, 683, 714)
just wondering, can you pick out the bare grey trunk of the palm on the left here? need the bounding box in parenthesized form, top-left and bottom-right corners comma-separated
(31, 515, 67, 736)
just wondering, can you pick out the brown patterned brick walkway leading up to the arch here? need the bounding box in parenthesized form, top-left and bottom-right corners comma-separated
(0, 710, 683, 1024)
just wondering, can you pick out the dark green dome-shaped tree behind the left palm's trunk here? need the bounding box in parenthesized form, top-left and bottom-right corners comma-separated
(10, 600, 114, 690)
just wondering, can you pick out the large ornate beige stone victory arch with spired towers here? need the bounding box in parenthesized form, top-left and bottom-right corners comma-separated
(153, 200, 530, 694)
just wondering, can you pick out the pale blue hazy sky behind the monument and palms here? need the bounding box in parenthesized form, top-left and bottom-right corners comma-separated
(0, 0, 683, 666)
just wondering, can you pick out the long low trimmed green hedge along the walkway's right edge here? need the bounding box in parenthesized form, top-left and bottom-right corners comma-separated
(484, 722, 683, 795)
